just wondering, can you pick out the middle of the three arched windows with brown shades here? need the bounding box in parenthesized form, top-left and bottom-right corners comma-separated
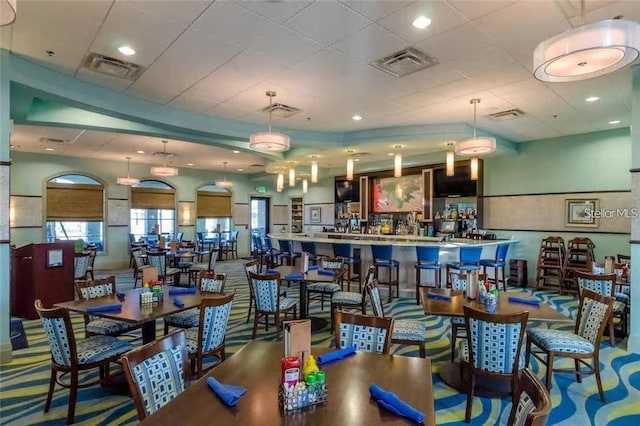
(131, 180, 176, 245)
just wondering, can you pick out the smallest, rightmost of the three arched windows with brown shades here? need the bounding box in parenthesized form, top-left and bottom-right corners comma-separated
(196, 185, 231, 236)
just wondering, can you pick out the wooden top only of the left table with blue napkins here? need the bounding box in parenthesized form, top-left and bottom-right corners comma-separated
(55, 285, 202, 323)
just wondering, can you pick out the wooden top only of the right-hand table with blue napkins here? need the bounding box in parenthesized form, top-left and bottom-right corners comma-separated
(420, 287, 574, 322)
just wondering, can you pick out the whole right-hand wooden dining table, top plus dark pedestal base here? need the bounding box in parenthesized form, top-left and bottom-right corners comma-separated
(420, 287, 575, 398)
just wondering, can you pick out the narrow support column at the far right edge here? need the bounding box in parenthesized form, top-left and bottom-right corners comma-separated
(627, 65, 640, 353)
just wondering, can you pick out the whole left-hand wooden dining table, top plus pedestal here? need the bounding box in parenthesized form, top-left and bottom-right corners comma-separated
(54, 285, 202, 343)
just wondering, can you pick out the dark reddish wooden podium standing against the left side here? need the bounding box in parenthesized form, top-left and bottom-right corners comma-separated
(11, 241, 75, 319)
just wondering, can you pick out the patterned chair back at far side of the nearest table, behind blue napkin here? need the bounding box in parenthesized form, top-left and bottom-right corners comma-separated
(335, 311, 393, 354)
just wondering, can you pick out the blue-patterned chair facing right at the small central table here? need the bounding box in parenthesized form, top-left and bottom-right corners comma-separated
(249, 272, 298, 340)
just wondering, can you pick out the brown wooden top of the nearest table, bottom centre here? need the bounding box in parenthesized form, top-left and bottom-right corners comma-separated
(142, 340, 436, 426)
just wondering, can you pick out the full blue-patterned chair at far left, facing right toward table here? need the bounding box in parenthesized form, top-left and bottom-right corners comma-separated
(34, 299, 133, 424)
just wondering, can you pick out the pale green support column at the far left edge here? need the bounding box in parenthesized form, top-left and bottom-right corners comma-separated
(0, 50, 12, 363)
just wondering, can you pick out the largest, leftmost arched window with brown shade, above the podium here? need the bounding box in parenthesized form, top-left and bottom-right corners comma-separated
(46, 174, 104, 251)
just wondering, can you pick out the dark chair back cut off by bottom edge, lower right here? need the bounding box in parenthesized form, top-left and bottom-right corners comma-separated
(507, 368, 551, 426)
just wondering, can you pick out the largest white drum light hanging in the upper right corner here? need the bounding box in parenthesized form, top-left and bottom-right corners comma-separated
(533, 0, 640, 83)
